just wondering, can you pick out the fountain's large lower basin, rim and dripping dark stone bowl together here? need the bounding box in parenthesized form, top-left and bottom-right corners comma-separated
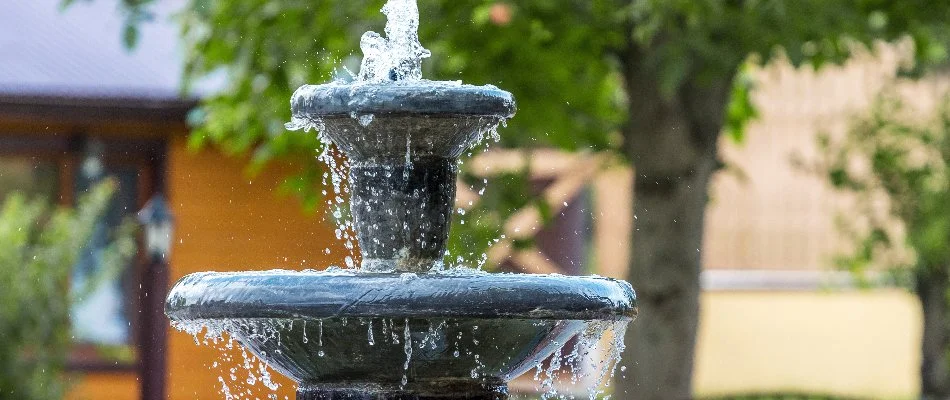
(166, 271, 636, 400)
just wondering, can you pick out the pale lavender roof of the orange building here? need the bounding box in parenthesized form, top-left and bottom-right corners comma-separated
(0, 0, 190, 103)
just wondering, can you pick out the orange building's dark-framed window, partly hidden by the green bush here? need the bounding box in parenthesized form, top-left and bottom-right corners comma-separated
(0, 136, 160, 370)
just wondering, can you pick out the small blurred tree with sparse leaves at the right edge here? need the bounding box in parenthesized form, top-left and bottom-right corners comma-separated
(818, 91, 950, 399)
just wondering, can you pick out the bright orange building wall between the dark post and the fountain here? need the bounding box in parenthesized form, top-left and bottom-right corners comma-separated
(167, 138, 347, 400)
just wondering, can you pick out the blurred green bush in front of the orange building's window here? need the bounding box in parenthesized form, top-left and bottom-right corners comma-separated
(0, 181, 136, 400)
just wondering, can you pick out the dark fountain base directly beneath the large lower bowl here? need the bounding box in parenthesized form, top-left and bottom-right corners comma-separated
(297, 380, 508, 400)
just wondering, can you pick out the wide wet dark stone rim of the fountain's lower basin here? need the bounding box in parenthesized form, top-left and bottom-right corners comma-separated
(165, 271, 637, 322)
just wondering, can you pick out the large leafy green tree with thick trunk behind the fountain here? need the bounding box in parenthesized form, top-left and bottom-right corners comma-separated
(102, 0, 950, 399)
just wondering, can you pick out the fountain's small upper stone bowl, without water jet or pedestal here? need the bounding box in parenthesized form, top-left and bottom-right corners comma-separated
(290, 80, 516, 163)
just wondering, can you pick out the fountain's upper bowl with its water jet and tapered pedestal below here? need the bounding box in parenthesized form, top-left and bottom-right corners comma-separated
(289, 0, 515, 272)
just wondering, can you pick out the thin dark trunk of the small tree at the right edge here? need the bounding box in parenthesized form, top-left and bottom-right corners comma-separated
(917, 271, 950, 400)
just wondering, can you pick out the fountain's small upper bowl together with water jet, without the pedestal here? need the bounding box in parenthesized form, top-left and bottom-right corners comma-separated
(291, 0, 515, 163)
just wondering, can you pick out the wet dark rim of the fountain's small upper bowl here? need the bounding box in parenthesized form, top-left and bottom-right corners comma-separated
(290, 81, 517, 119)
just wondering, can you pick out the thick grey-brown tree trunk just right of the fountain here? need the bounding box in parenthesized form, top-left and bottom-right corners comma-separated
(614, 42, 738, 400)
